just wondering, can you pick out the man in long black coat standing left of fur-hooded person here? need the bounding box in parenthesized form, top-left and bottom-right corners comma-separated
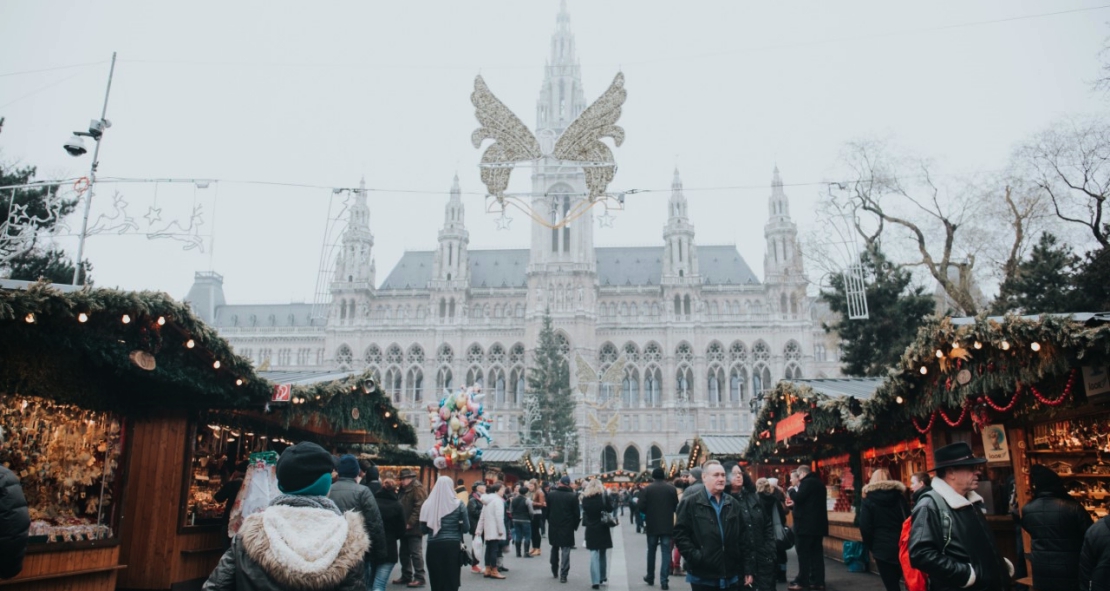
(786, 465, 829, 591)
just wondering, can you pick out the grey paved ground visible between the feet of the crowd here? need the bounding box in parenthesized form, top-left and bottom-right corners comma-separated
(455, 512, 882, 591)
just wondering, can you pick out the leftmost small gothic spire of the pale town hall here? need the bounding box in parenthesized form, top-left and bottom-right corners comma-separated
(331, 177, 375, 325)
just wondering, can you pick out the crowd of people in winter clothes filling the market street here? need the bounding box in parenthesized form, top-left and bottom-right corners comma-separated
(0, 428, 1110, 591)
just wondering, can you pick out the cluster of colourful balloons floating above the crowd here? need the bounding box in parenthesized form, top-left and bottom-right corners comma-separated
(427, 387, 493, 470)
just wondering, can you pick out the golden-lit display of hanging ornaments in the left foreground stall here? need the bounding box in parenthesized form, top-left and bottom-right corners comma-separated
(0, 394, 123, 542)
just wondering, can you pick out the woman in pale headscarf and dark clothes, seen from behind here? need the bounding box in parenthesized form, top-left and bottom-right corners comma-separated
(420, 477, 471, 591)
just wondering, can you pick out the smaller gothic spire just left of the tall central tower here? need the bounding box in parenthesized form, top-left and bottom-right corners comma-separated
(428, 174, 471, 319)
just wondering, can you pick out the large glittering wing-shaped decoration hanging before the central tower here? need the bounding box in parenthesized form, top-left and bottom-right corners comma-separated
(471, 73, 628, 229)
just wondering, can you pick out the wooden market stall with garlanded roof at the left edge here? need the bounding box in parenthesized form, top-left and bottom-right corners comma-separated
(0, 280, 265, 590)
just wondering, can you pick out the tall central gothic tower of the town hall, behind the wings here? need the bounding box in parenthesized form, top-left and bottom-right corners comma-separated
(528, 2, 597, 322)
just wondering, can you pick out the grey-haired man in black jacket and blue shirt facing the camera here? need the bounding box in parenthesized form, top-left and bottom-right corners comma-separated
(675, 460, 754, 591)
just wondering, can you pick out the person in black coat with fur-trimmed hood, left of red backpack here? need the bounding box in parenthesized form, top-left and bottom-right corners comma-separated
(859, 468, 909, 591)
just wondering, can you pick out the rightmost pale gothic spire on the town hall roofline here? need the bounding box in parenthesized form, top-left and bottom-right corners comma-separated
(764, 166, 806, 318)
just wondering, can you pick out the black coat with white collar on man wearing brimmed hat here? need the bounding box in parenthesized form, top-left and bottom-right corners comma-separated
(909, 479, 1012, 591)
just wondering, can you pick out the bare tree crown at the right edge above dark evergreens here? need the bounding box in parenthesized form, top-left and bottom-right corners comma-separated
(1017, 118, 1110, 248)
